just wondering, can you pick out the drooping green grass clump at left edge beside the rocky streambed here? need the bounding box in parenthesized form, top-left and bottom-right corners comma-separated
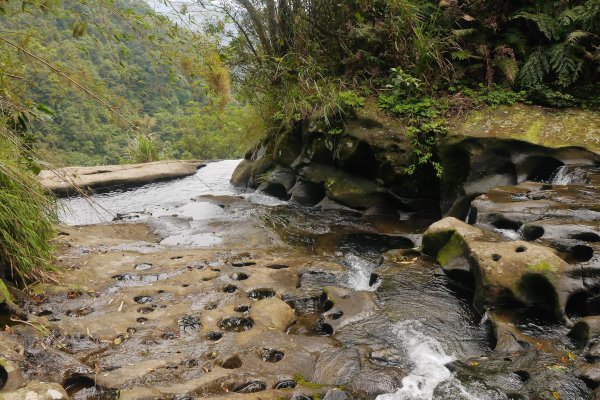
(0, 128, 56, 286)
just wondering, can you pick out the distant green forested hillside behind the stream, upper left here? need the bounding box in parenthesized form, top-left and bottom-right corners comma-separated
(0, 0, 262, 165)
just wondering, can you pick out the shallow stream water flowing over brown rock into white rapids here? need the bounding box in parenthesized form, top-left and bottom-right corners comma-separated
(61, 160, 576, 400)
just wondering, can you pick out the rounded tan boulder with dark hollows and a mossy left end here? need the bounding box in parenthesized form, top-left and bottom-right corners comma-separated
(423, 218, 583, 319)
